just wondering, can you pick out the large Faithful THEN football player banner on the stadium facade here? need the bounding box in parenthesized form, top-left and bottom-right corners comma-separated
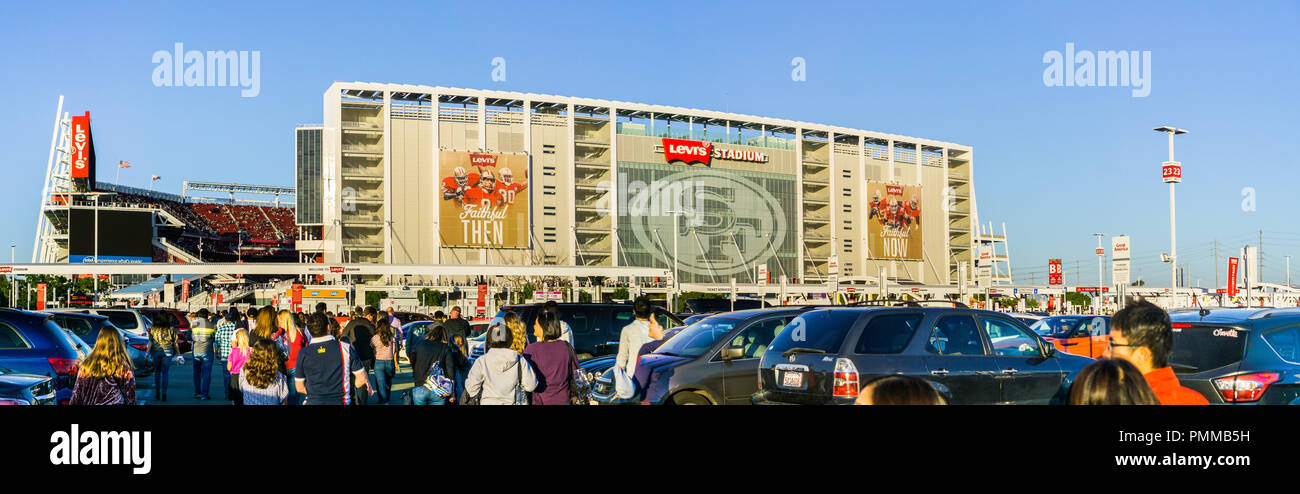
(438, 151, 528, 248)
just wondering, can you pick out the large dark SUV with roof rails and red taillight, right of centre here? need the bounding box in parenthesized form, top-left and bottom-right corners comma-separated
(753, 306, 1092, 404)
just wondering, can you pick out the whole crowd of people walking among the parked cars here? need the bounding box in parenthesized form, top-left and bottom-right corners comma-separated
(63, 296, 1209, 406)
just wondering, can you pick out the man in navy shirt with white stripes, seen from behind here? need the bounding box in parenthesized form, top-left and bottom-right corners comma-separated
(294, 313, 374, 404)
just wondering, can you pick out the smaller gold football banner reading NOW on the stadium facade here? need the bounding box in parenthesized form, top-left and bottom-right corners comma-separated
(867, 182, 920, 260)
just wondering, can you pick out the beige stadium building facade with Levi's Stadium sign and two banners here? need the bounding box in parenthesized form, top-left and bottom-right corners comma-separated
(296, 82, 978, 285)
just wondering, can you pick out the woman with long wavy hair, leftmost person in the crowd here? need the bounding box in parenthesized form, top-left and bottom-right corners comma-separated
(68, 326, 135, 404)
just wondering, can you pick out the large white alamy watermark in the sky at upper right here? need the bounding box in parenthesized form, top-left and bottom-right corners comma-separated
(1043, 43, 1151, 98)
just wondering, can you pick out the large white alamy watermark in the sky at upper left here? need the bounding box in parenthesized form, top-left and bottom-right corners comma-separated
(152, 42, 261, 98)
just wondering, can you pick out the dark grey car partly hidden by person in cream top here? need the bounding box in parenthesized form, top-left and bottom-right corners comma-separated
(592, 307, 813, 404)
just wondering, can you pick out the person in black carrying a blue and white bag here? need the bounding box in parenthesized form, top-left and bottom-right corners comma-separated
(407, 322, 464, 404)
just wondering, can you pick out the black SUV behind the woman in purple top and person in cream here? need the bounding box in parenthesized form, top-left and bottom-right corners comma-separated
(486, 303, 681, 360)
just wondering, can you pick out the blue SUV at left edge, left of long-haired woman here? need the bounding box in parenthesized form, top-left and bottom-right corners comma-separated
(0, 308, 78, 404)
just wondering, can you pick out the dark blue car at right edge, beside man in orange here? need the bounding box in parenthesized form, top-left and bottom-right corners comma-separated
(1169, 308, 1300, 404)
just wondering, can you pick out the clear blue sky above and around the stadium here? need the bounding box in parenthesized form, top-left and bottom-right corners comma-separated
(0, 1, 1300, 286)
